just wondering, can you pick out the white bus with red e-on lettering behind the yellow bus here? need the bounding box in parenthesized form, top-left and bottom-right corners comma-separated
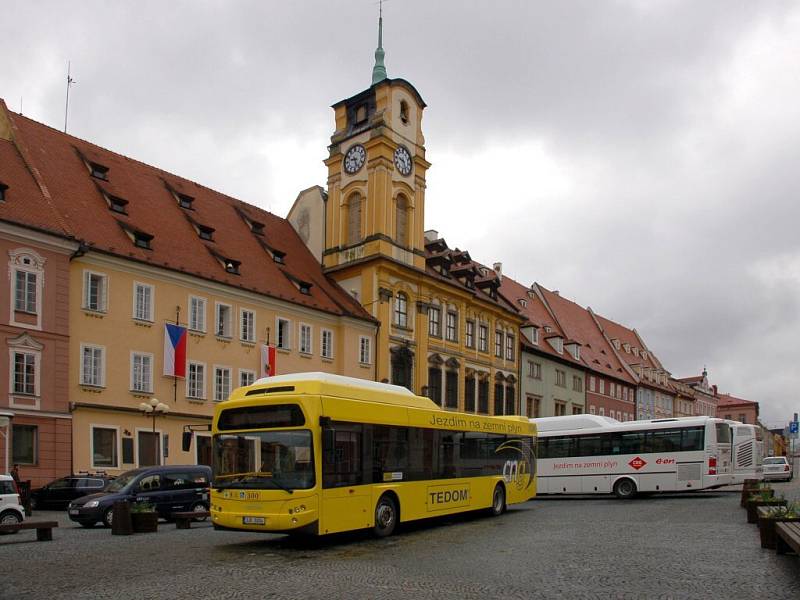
(531, 415, 732, 498)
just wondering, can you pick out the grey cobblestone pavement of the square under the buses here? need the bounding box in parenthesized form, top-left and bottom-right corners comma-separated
(0, 480, 800, 600)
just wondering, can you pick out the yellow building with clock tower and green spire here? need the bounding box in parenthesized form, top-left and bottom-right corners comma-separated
(289, 22, 524, 414)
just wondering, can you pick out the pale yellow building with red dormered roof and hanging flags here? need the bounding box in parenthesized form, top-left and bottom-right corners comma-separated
(3, 104, 377, 475)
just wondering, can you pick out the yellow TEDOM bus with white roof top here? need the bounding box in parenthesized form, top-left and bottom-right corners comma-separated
(203, 373, 536, 536)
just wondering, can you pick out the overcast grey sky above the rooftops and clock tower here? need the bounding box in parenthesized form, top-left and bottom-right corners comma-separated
(0, 0, 800, 425)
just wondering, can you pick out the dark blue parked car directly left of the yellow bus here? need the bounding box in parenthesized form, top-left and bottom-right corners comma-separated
(68, 465, 211, 527)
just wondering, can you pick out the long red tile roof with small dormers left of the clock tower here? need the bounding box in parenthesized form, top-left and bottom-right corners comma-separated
(0, 100, 373, 320)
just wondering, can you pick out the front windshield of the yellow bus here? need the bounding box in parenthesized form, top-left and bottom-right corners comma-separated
(214, 430, 314, 493)
